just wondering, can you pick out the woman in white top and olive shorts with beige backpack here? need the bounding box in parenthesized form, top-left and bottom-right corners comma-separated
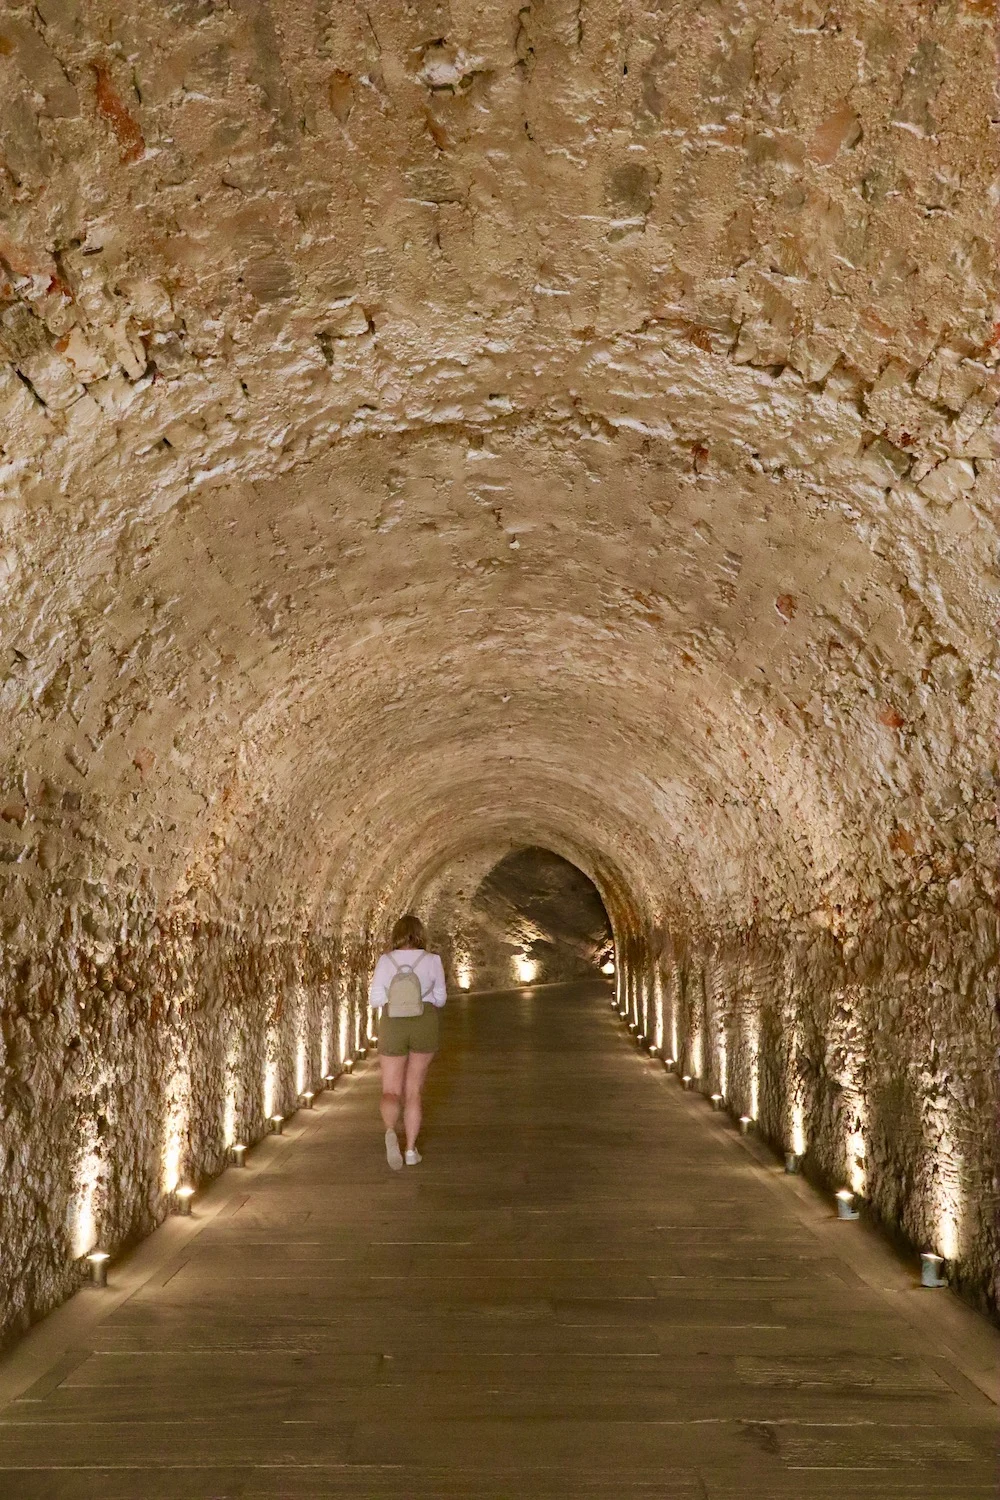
(369, 912, 447, 1172)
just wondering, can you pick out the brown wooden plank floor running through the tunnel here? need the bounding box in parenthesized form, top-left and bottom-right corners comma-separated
(0, 986, 997, 1500)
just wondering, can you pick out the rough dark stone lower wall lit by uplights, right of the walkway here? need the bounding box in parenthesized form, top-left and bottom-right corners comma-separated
(620, 908, 1000, 1313)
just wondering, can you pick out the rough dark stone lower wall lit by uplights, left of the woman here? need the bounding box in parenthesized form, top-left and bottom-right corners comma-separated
(0, 887, 360, 1344)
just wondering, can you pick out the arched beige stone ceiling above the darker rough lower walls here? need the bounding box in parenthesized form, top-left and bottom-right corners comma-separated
(0, 0, 1000, 927)
